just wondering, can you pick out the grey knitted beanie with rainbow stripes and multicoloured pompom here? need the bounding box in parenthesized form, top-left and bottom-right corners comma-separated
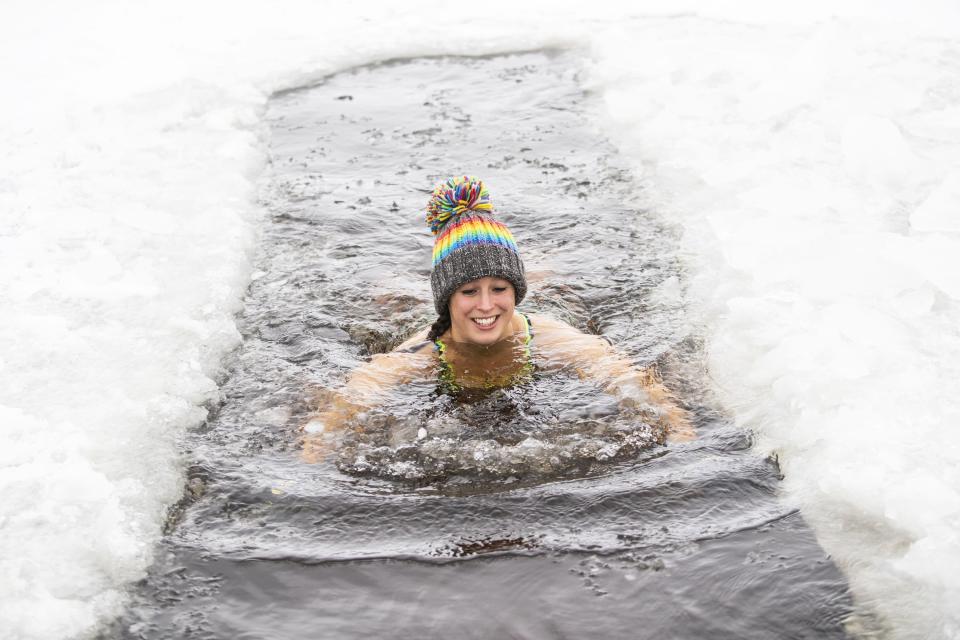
(427, 176, 527, 313)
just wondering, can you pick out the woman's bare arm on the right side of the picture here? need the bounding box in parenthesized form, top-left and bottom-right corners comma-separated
(533, 315, 696, 441)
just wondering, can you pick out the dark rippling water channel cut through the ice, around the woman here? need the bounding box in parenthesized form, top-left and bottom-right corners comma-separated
(109, 53, 851, 640)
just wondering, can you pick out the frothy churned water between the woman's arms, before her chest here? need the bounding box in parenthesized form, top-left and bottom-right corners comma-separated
(338, 373, 664, 484)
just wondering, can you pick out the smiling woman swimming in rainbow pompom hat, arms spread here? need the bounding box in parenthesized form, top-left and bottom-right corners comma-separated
(303, 176, 695, 462)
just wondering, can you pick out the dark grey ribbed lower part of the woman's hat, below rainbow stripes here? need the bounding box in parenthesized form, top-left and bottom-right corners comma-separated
(430, 243, 527, 313)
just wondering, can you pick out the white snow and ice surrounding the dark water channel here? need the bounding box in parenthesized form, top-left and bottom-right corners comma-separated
(0, 0, 960, 639)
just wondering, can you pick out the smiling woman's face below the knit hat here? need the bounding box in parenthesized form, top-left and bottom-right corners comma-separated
(449, 277, 516, 345)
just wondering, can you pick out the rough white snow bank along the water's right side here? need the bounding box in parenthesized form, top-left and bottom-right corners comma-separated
(594, 7, 960, 638)
